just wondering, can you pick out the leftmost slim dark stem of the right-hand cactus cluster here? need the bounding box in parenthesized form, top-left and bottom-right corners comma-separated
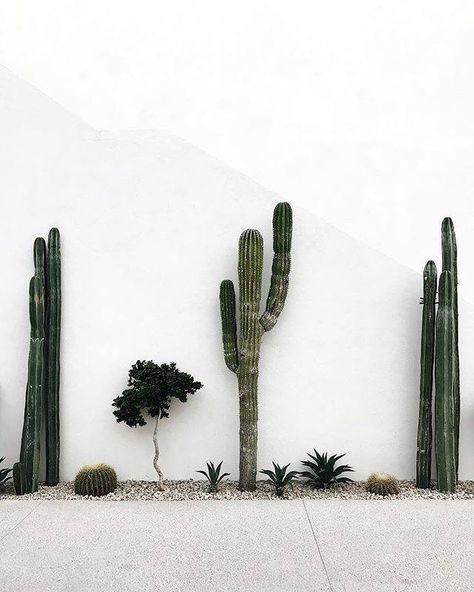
(416, 261, 437, 489)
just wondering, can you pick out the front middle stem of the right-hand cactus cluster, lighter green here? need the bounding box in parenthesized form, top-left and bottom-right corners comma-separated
(435, 271, 456, 492)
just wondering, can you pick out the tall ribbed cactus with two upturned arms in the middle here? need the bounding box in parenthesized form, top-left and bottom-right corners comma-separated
(220, 202, 292, 491)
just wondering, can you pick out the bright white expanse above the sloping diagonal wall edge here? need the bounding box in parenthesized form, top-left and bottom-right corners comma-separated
(0, 0, 474, 302)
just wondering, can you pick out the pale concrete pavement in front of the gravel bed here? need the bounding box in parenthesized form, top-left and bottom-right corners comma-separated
(0, 498, 474, 592)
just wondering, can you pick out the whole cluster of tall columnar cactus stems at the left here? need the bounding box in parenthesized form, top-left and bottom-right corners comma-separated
(13, 228, 61, 495)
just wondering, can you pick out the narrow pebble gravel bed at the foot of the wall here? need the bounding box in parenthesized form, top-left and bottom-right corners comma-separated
(0, 479, 474, 502)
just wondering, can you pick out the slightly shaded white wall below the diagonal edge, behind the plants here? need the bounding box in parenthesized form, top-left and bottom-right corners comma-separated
(0, 70, 474, 479)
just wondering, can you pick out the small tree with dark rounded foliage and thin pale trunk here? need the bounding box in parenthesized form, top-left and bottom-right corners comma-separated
(112, 360, 203, 490)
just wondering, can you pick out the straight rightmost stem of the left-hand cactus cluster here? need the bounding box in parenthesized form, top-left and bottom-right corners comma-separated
(45, 228, 61, 485)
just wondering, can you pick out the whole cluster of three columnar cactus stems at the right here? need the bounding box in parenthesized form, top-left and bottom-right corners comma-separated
(416, 218, 460, 492)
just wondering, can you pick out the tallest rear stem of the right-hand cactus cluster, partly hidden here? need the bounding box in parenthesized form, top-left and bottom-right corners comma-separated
(441, 218, 461, 481)
